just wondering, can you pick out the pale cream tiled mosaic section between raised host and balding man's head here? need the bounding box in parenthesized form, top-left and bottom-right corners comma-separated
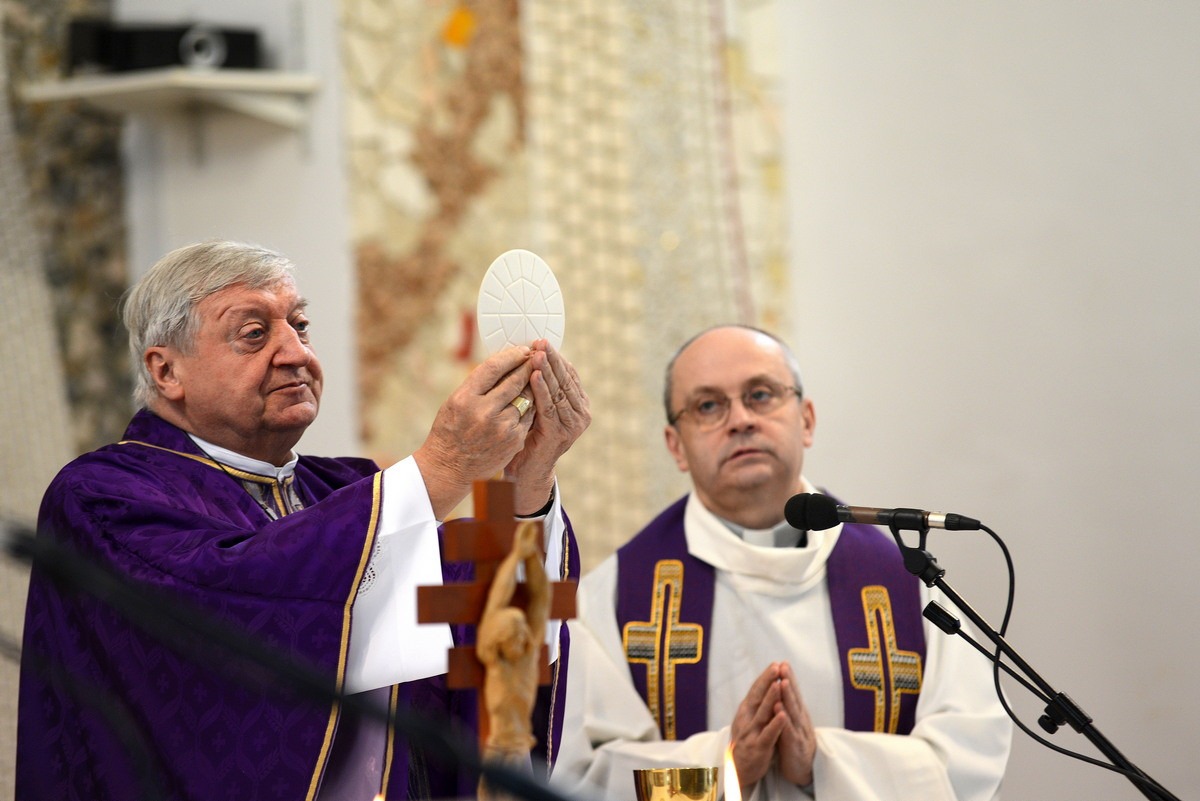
(526, 0, 785, 564)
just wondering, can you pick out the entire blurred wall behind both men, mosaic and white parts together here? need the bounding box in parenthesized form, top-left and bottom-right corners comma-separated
(0, 0, 1200, 801)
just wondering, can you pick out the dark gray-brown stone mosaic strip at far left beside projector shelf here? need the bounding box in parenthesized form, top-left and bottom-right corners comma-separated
(2, 0, 132, 452)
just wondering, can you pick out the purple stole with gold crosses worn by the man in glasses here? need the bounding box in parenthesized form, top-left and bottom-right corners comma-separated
(617, 495, 925, 740)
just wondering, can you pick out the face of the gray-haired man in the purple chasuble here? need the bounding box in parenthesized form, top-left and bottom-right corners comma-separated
(146, 281, 323, 464)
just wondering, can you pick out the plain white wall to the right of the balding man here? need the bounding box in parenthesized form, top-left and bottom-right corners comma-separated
(782, 0, 1200, 801)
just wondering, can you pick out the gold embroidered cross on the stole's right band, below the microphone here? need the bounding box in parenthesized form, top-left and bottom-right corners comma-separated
(846, 585, 920, 734)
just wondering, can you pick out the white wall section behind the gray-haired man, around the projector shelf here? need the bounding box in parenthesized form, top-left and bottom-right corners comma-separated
(114, 0, 359, 456)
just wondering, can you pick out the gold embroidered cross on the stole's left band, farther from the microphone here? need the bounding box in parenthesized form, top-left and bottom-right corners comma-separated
(622, 559, 704, 740)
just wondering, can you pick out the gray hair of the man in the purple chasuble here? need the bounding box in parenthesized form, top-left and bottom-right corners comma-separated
(122, 240, 293, 408)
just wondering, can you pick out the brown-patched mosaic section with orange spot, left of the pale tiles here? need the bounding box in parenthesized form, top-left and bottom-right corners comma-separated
(343, 0, 529, 464)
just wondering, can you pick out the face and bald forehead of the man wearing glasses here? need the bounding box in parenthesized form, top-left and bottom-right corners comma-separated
(666, 327, 816, 528)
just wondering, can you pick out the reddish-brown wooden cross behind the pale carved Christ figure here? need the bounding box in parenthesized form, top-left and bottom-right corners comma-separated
(416, 481, 575, 746)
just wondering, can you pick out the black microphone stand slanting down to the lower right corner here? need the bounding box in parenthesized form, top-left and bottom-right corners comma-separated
(889, 508, 1180, 801)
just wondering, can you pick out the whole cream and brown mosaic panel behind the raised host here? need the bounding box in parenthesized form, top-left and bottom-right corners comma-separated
(342, 0, 786, 566)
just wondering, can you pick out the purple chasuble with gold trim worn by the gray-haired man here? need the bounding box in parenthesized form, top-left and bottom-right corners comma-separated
(16, 410, 578, 801)
